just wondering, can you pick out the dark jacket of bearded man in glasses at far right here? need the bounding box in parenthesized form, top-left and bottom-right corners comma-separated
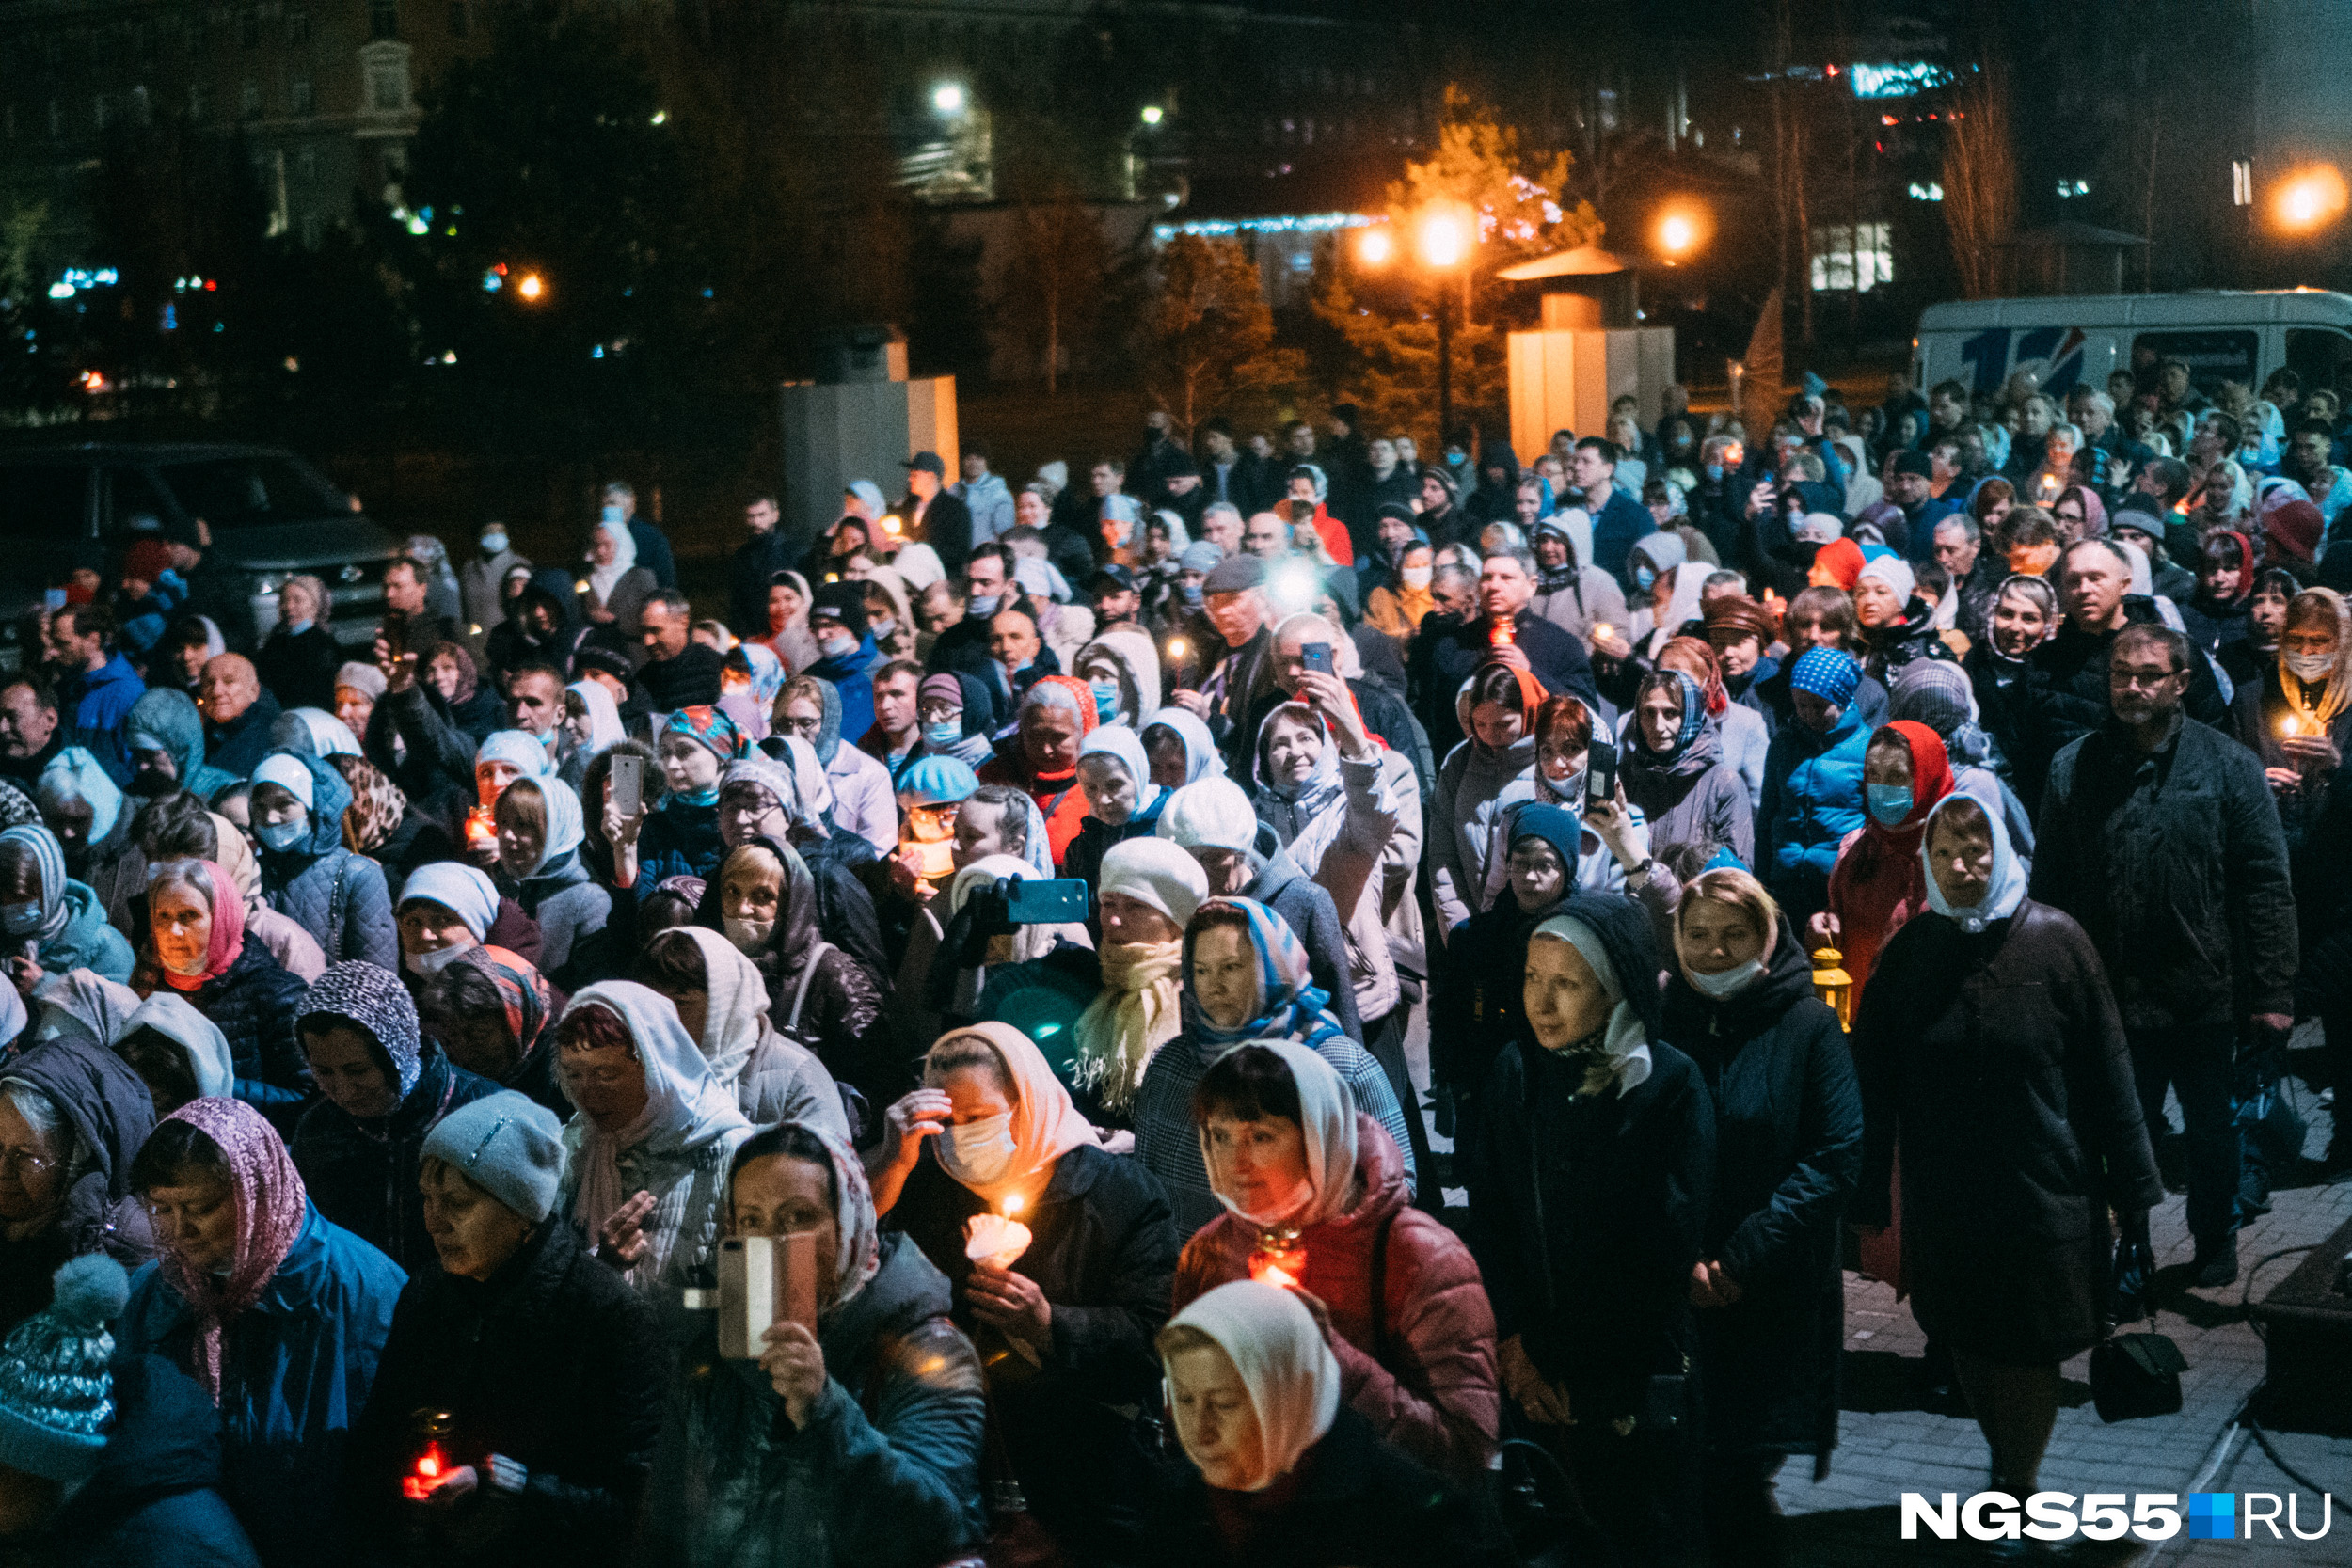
(2032, 720, 2296, 1030)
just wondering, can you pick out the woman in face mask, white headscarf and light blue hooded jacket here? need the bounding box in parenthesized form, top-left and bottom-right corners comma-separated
(252, 752, 400, 969)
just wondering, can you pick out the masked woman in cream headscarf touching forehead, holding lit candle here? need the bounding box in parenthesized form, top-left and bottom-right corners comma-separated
(873, 1022, 1179, 1561)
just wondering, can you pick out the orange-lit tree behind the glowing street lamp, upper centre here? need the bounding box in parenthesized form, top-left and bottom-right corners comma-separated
(1315, 87, 1602, 441)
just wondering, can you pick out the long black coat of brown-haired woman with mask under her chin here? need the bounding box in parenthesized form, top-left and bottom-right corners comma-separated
(1665, 922, 1863, 1479)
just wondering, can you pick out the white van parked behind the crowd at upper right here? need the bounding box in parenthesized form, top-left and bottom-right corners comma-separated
(1913, 289, 2352, 408)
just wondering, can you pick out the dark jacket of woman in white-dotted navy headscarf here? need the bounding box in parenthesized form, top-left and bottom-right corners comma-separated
(292, 1041, 499, 1275)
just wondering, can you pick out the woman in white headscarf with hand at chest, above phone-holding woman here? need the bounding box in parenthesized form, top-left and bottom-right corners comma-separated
(555, 980, 751, 1300)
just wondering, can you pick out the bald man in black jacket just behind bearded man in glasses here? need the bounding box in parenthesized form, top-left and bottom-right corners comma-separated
(2009, 538, 2228, 811)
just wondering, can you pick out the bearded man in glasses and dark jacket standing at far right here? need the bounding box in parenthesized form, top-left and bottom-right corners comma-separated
(2032, 626, 2296, 1286)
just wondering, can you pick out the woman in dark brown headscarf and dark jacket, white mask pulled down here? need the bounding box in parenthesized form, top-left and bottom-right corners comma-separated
(694, 837, 906, 1105)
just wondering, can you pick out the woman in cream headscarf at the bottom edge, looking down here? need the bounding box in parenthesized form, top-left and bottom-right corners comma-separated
(1141, 1278, 1513, 1568)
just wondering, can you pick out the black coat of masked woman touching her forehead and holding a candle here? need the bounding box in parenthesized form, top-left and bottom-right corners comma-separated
(882, 1148, 1184, 1561)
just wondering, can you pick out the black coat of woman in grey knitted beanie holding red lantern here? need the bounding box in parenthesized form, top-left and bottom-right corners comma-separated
(343, 1215, 671, 1568)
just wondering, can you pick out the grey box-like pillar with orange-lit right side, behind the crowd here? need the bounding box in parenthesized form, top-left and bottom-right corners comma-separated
(776, 325, 960, 543)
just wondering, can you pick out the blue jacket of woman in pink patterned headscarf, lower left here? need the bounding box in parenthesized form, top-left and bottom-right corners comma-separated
(116, 1201, 409, 1568)
